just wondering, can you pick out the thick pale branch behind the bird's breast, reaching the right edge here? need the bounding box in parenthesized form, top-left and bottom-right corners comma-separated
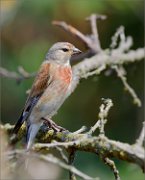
(72, 48, 145, 91)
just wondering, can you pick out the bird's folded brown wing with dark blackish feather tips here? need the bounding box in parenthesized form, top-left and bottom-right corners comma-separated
(13, 63, 50, 134)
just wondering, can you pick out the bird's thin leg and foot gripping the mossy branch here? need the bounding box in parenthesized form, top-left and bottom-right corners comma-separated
(42, 118, 66, 132)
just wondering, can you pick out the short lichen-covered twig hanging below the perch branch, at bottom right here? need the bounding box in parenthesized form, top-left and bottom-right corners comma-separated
(103, 157, 120, 180)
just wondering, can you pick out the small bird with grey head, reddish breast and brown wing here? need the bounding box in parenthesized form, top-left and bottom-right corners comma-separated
(13, 42, 81, 150)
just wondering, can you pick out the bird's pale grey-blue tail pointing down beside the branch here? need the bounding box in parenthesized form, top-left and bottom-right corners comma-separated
(26, 122, 42, 150)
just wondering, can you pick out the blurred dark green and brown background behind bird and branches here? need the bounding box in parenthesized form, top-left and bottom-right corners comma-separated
(0, 0, 144, 180)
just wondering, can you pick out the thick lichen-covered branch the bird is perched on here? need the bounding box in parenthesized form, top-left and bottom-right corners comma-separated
(0, 124, 145, 169)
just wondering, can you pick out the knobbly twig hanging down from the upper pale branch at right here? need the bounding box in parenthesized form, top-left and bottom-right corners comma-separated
(112, 66, 141, 107)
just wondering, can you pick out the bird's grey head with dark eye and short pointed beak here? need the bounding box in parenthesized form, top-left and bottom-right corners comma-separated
(45, 42, 81, 64)
